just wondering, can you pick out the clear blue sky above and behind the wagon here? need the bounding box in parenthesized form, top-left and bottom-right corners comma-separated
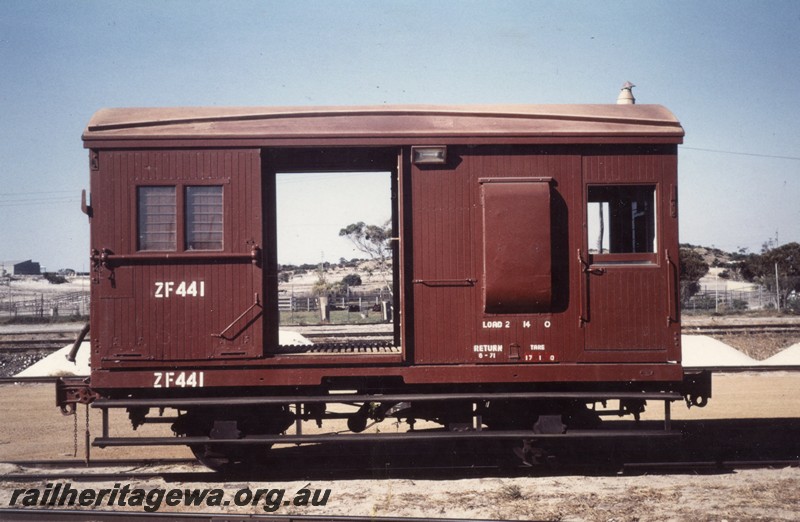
(0, 0, 800, 270)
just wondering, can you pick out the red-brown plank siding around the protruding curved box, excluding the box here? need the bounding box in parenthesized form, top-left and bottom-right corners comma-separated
(411, 147, 583, 363)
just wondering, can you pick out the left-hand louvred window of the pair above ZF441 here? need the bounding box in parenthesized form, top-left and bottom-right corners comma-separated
(137, 187, 177, 250)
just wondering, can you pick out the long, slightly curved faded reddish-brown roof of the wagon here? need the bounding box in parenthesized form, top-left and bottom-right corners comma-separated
(83, 105, 683, 147)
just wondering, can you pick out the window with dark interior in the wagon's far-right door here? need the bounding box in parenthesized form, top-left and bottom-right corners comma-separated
(587, 185, 657, 254)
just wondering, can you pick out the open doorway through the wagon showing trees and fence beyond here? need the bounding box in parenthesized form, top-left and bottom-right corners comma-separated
(262, 148, 400, 355)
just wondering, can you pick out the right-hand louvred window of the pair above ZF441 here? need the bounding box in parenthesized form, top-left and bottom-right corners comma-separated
(186, 186, 223, 250)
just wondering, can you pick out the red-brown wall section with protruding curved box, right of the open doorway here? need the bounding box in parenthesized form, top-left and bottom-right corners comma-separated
(410, 147, 583, 364)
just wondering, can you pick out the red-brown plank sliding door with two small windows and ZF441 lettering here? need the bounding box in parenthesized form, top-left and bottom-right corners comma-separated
(92, 150, 263, 367)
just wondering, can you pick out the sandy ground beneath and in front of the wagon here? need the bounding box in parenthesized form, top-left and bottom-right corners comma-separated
(0, 372, 800, 521)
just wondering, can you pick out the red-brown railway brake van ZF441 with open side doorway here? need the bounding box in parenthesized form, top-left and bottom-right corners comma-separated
(59, 101, 710, 468)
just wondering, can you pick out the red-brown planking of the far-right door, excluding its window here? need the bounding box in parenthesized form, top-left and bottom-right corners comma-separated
(581, 147, 679, 362)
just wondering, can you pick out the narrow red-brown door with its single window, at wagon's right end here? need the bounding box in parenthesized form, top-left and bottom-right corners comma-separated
(575, 154, 678, 362)
